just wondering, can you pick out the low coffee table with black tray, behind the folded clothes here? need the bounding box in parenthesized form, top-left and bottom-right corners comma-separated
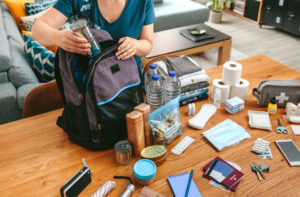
(142, 24, 232, 66)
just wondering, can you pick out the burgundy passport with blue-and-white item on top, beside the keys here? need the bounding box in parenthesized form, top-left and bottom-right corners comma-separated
(203, 157, 244, 191)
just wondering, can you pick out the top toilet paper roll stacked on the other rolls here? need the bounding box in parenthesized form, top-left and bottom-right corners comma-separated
(222, 61, 243, 86)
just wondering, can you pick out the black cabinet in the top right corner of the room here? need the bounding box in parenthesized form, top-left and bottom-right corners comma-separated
(260, 0, 300, 36)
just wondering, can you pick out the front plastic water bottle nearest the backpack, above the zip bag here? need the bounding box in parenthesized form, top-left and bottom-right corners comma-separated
(146, 74, 163, 110)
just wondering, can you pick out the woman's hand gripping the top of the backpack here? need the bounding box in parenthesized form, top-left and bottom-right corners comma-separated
(116, 37, 137, 60)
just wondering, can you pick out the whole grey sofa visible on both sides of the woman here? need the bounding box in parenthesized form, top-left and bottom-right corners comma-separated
(0, 0, 209, 124)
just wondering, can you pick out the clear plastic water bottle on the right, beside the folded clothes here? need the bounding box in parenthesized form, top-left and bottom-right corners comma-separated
(163, 71, 181, 103)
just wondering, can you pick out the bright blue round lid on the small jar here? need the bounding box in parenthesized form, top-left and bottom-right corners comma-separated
(133, 159, 156, 180)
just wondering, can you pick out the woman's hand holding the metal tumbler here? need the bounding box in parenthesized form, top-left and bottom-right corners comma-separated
(58, 30, 91, 55)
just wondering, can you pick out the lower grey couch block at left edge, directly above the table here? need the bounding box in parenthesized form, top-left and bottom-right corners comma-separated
(0, 83, 22, 124)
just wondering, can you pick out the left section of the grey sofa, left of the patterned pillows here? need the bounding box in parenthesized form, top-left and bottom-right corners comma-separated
(0, 1, 40, 124)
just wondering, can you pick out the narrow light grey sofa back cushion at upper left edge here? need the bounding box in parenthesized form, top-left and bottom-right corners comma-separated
(0, 6, 10, 72)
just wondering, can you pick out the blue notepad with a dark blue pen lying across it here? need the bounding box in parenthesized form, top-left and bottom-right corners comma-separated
(167, 172, 202, 197)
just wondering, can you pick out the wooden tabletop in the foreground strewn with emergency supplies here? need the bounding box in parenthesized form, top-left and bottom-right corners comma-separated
(0, 55, 300, 197)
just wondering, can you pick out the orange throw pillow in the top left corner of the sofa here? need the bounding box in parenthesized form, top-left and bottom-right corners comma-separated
(2, 0, 34, 30)
